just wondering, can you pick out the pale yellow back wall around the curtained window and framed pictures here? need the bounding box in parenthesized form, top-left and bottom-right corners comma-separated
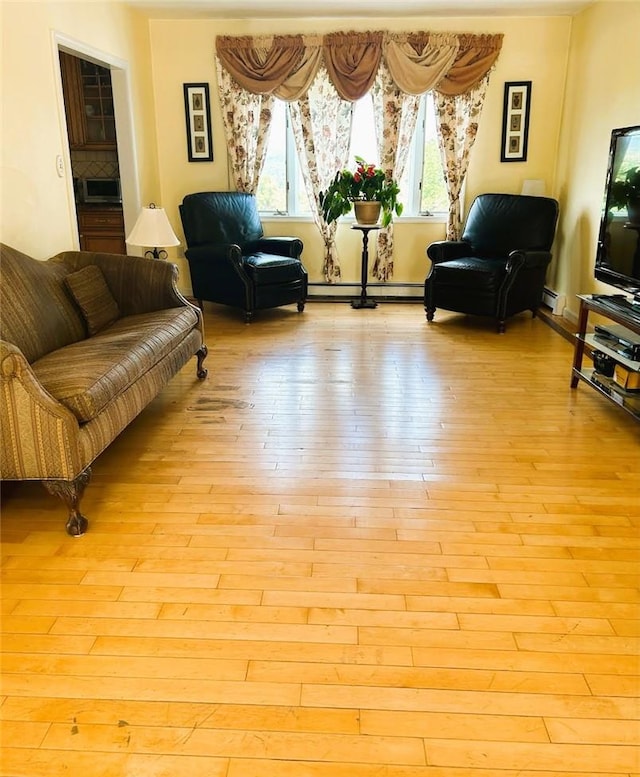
(150, 17, 571, 292)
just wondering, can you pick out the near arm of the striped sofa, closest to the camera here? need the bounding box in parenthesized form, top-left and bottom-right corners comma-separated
(0, 340, 85, 480)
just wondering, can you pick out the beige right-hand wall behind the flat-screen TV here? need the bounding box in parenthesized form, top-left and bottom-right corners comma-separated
(549, 0, 640, 316)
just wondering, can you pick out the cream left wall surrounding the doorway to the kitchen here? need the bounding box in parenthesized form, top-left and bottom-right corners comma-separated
(0, 2, 157, 259)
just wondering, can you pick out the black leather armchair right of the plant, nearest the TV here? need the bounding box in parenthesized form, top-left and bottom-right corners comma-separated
(424, 194, 558, 332)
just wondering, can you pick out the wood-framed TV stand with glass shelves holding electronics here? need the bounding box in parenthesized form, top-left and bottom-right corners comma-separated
(571, 295, 640, 421)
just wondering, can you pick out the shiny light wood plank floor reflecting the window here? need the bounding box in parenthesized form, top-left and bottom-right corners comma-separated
(0, 303, 640, 777)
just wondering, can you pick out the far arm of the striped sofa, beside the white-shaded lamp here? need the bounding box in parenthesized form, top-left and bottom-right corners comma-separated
(50, 251, 190, 316)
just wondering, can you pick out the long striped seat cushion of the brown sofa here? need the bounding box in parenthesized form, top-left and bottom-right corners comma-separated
(31, 307, 198, 423)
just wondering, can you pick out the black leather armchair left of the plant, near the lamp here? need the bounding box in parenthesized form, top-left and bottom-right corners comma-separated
(180, 192, 308, 323)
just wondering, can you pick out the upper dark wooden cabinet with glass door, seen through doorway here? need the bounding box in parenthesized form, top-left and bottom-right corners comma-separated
(60, 51, 116, 150)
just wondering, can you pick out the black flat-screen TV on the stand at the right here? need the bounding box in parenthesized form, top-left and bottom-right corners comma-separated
(595, 125, 640, 303)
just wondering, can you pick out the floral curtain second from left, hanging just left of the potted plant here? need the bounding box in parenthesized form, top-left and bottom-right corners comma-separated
(289, 68, 352, 283)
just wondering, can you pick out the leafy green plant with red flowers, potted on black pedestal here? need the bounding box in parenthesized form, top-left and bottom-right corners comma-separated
(320, 156, 402, 227)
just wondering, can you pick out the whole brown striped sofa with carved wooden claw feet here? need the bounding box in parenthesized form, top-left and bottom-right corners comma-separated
(0, 244, 207, 536)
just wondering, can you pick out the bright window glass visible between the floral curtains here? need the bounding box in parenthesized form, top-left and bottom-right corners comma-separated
(257, 94, 448, 216)
